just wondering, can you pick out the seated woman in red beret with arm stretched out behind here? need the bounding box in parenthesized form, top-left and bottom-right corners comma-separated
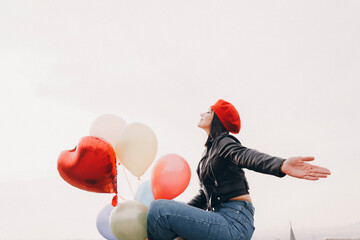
(147, 99, 330, 240)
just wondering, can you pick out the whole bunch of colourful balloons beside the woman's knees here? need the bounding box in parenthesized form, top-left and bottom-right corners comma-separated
(57, 114, 191, 240)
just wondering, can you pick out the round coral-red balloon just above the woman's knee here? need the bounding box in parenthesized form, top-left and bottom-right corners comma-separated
(151, 154, 191, 200)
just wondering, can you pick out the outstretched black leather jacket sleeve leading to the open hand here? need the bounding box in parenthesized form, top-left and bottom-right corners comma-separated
(219, 138, 286, 177)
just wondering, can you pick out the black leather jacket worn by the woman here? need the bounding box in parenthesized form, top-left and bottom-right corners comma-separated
(188, 133, 285, 210)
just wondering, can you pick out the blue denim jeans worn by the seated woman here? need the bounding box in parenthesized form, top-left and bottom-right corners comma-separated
(147, 199, 255, 240)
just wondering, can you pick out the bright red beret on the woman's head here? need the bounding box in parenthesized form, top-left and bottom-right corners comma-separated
(211, 99, 241, 133)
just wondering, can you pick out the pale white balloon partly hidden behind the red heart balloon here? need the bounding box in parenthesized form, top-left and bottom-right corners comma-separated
(90, 114, 126, 148)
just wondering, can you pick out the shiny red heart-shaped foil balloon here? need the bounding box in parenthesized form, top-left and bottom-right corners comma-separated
(57, 136, 117, 193)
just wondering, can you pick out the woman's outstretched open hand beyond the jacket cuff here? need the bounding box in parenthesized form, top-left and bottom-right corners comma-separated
(281, 157, 331, 180)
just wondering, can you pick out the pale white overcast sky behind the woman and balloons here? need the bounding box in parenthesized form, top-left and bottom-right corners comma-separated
(0, 0, 360, 240)
